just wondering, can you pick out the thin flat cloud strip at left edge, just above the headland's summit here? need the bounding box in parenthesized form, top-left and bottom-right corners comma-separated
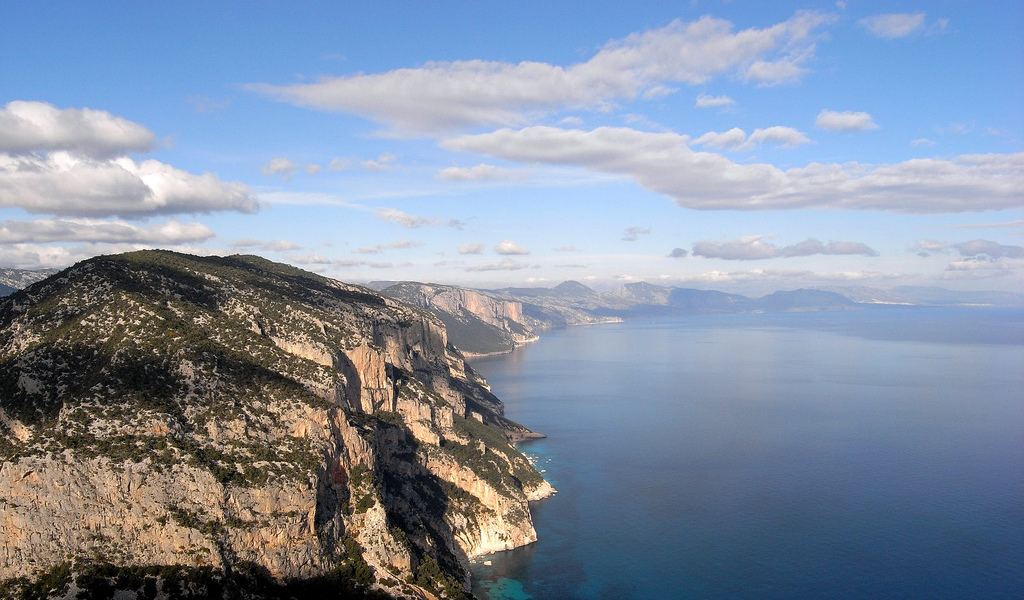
(0, 219, 214, 246)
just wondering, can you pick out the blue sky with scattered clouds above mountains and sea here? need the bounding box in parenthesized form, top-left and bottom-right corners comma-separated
(0, 0, 1024, 294)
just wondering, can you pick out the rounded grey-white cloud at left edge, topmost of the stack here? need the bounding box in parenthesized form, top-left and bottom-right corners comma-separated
(0, 100, 154, 159)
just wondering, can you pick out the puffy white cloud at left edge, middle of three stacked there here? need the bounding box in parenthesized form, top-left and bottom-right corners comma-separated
(0, 152, 259, 217)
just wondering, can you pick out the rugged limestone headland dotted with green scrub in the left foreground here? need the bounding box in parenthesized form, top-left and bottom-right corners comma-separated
(0, 252, 551, 596)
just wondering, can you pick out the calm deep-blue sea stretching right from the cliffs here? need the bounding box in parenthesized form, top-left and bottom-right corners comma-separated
(474, 309, 1024, 600)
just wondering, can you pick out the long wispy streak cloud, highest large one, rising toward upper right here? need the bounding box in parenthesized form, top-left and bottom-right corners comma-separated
(247, 11, 836, 133)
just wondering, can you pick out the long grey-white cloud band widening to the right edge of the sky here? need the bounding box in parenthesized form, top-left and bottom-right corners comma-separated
(441, 126, 1024, 213)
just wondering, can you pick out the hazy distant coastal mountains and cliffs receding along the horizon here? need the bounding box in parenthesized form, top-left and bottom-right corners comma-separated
(370, 282, 1024, 354)
